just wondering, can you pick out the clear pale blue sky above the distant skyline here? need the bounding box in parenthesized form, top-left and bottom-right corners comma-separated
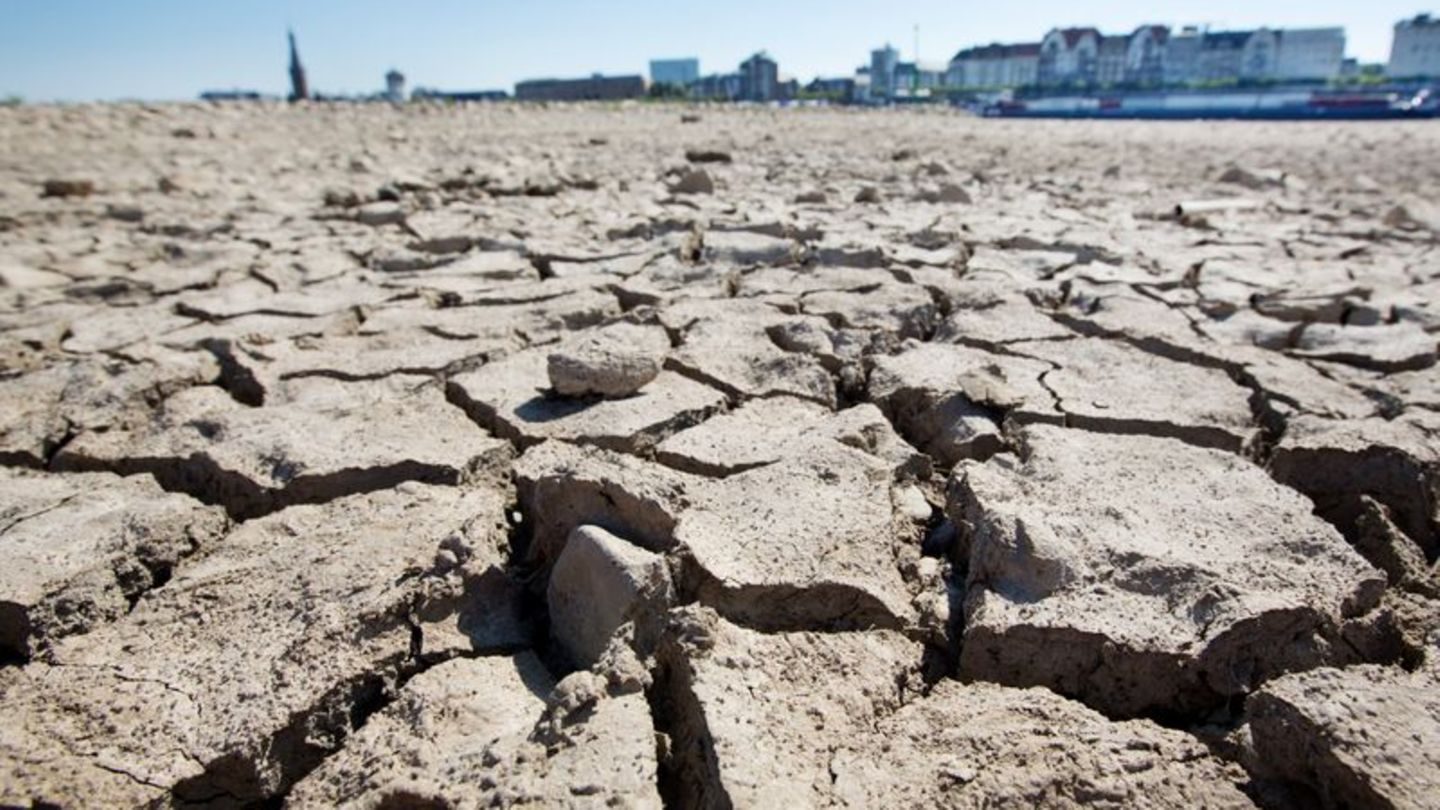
(0, 0, 1440, 101)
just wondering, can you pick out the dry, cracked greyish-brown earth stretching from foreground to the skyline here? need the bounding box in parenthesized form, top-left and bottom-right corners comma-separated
(0, 104, 1440, 809)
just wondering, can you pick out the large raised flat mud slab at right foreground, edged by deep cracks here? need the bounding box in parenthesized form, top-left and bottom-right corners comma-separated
(950, 425, 1385, 716)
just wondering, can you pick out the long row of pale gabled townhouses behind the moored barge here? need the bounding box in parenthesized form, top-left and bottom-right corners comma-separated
(946, 26, 1345, 88)
